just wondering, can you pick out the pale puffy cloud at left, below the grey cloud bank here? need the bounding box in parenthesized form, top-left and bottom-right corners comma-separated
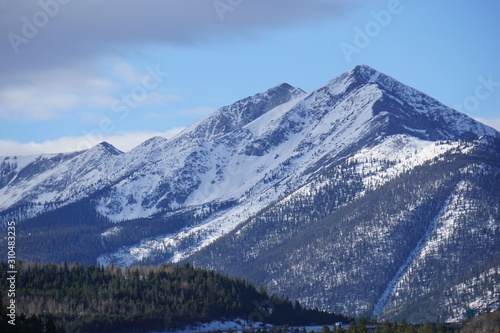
(0, 58, 182, 121)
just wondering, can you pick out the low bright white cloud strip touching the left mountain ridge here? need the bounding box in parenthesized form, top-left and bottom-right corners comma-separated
(0, 127, 184, 156)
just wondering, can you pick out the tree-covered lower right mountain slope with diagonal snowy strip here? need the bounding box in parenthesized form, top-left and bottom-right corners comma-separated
(189, 136, 500, 321)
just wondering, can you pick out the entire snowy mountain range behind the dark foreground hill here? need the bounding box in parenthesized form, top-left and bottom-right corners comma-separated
(0, 66, 500, 321)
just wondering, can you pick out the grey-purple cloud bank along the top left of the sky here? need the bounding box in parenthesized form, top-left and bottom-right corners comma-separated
(0, 0, 358, 74)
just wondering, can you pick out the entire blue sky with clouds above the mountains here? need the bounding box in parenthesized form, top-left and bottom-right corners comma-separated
(0, 0, 500, 155)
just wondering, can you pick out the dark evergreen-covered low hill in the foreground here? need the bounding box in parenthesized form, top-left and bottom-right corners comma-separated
(0, 263, 349, 332)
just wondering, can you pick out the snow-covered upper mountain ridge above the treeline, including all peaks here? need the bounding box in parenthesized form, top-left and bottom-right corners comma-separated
(0, 66, 497, 217)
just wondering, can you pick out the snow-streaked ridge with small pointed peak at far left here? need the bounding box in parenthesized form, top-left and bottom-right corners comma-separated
(0, 142, 123, 225)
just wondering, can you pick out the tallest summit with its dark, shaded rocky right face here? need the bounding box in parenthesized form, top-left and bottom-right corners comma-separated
(307, 65, 499, 141)
